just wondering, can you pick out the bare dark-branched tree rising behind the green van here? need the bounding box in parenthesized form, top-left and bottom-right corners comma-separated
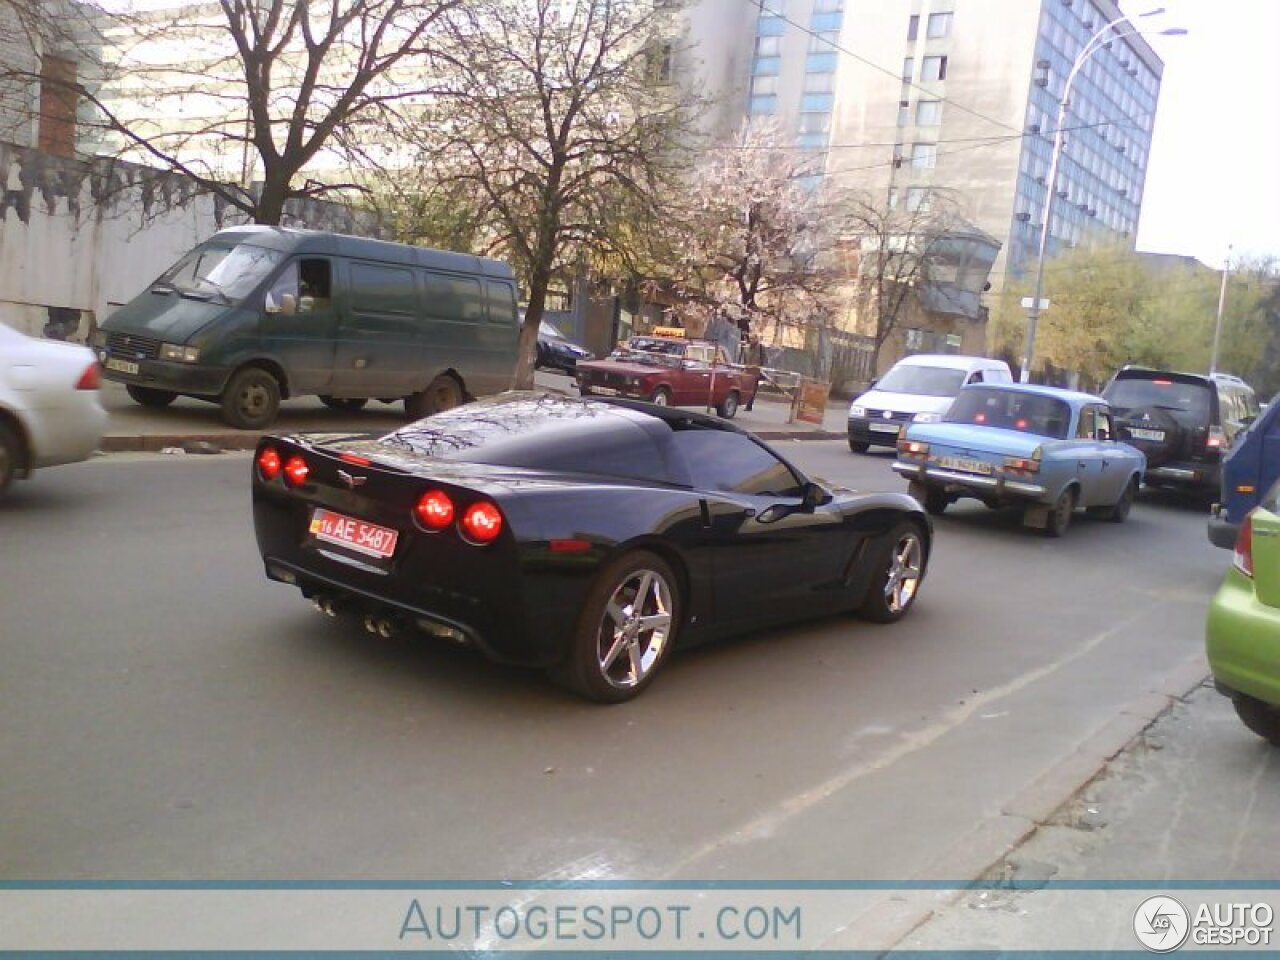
(0, 0, 462, 224)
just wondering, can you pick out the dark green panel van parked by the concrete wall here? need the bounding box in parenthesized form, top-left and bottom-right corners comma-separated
(92, 227, 520, 430)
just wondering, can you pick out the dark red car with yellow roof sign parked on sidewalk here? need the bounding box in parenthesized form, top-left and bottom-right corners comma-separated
(576, 328, 760, 419)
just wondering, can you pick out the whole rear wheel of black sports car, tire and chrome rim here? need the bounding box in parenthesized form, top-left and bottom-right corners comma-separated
(548, 550, 682, 703)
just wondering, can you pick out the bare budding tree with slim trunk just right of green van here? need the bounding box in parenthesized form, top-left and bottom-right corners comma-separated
(401, 0, 691, 388)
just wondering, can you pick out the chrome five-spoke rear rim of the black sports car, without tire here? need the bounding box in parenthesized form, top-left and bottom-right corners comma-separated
(595, 570, 672, 690)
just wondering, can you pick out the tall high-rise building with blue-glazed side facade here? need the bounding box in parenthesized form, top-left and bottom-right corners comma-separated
(690, 0, 1164, 285)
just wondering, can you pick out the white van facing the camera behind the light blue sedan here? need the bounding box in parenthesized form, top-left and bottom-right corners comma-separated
(849, 353, 1014, 453)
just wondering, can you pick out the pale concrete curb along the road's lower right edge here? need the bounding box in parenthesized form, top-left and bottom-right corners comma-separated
(820, 655, 1208, 952)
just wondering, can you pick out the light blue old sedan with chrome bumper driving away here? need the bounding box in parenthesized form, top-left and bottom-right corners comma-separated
(893, 384, 1147, 536)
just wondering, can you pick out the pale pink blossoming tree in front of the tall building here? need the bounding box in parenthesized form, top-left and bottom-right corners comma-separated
(664, 123, 841, 343)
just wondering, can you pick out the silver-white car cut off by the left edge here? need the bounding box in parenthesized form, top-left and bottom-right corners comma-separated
(0, 324, 106, 504)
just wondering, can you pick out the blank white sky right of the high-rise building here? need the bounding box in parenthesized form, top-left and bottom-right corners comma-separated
(1121, 0, 1280, 268)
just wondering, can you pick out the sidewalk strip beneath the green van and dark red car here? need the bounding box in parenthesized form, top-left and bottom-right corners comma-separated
(92, 372, 847, 453)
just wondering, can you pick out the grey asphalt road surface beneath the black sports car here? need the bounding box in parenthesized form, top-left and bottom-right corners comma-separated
(0, 442, 1228, 879)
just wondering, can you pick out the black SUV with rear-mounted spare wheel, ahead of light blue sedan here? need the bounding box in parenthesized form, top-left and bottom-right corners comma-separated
(1102, 366, 1258, 494)
